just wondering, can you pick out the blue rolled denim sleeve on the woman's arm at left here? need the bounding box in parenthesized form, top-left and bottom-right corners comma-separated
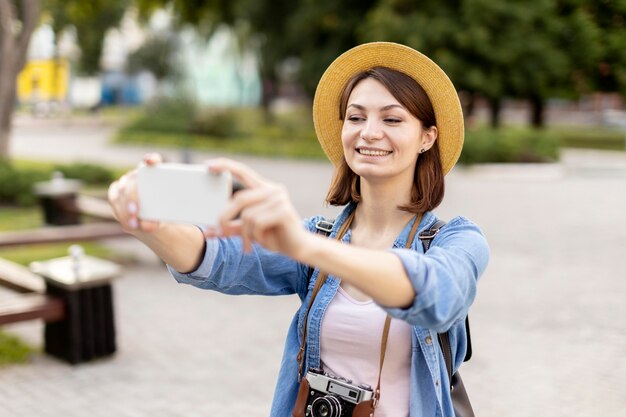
(168, 218, 317, 295)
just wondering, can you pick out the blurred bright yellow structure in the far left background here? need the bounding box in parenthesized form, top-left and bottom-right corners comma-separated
(17, 59, 70, 103)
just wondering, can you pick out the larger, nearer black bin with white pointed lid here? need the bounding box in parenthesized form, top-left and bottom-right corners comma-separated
(30, 245, 121, 364)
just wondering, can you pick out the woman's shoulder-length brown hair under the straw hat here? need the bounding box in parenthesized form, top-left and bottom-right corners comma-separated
(326, 67, 444, 213)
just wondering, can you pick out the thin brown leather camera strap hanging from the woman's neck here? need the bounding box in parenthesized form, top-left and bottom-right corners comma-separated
(296, 210, 422, 408)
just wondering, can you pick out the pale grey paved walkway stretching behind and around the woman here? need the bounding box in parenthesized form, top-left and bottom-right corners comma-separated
(0, 114, 626, 417)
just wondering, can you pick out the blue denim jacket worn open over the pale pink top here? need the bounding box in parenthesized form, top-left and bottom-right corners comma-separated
(170, 204, 489, 417)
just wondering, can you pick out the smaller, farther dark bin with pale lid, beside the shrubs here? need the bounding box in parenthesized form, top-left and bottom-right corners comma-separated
(33, 171, 82, 226)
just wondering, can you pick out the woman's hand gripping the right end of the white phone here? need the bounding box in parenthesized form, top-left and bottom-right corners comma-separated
(207, 158, 306, 257)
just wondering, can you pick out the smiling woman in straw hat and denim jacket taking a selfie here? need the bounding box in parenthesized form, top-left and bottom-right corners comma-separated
(110, 42, 489, 417)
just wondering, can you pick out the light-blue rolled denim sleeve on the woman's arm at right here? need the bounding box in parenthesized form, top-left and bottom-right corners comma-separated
(385, 217, 489, 333)
